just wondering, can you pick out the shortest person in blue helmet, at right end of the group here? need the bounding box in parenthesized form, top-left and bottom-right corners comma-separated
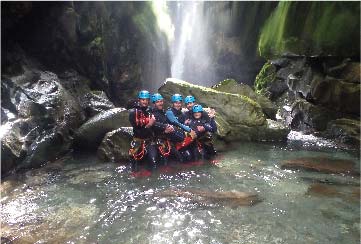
(189, 105, 217, 159)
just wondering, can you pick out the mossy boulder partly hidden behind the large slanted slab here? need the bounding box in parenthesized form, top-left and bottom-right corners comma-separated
(212, 79, 277, 119)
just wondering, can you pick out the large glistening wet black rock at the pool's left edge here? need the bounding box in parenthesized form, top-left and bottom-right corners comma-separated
(2, 72, 85, 172)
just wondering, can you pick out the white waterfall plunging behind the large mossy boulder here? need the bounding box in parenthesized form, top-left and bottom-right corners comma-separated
(171, 2, 214, 85)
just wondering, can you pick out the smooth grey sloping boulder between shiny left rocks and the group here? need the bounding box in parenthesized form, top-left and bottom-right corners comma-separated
(74, 108, 131, 150)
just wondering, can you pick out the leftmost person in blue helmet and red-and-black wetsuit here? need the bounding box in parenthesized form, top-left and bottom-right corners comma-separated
(129, 90, 159, 171)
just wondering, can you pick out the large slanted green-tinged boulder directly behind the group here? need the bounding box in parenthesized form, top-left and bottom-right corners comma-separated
(159, 78, 286, 141)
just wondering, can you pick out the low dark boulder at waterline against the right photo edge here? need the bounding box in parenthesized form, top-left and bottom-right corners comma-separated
(325, 118, 360, 146)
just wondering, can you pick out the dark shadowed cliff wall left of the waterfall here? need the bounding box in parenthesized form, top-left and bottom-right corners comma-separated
(2, 2, 170, 106)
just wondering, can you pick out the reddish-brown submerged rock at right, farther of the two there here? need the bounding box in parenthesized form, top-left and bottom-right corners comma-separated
(281, 157, 360, 175)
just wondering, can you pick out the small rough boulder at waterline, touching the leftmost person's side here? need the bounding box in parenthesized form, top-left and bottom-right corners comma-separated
(97, 127, 133, 162)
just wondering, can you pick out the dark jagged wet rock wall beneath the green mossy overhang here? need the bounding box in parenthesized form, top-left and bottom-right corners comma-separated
(255, 56, 360, 145)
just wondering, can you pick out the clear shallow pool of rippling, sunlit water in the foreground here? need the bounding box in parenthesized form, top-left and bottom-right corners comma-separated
(1, 143, 360, 244)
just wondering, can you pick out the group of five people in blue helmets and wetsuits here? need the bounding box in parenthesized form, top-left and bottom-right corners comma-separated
(129, 90, 217, 172)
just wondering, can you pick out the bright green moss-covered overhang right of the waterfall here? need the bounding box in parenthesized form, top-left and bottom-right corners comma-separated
(258, 1, 360, 58)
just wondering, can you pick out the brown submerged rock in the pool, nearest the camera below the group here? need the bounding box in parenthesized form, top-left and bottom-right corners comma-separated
(156, 189, 261, 208)
